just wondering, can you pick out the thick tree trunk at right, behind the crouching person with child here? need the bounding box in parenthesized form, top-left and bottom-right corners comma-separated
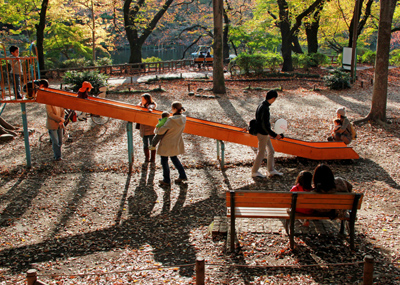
(356, 0, 397, 123)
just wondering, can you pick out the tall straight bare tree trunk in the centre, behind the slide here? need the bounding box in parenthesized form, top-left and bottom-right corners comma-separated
(213, 0, 226, 94)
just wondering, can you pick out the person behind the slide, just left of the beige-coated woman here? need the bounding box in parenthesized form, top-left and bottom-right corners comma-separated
(139, 93, 157, 163)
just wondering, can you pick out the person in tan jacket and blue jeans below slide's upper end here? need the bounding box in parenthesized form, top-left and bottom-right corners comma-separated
(46, 105, 65, 161)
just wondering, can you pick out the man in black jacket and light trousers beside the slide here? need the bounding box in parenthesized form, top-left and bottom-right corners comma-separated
(251, 90, 283, 178)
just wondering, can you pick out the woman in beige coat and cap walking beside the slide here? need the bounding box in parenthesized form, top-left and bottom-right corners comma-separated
(155, 101, 187, 186)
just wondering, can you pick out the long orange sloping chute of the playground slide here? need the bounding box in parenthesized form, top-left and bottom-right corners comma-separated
(36, 88, 359, 160)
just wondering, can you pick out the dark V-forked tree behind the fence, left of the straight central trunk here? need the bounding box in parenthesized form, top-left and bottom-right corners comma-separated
(123, 0, 174, 63)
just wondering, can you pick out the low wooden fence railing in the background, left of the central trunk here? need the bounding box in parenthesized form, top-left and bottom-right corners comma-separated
(41, 59, 193, 78)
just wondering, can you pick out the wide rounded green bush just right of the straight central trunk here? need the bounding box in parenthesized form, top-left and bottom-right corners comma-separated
(233, 52, 283, 74)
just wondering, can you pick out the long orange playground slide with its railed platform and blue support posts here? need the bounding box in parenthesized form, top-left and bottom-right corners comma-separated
(0, 40, 359, 169)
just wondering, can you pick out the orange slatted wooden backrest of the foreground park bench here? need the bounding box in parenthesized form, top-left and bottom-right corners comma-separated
(226, 190, 363, 210)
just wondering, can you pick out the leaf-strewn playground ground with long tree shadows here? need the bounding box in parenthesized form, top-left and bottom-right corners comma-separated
(0, 68, 400, 284)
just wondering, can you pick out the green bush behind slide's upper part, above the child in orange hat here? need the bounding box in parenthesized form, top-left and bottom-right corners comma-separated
(62, 70, 109, 94)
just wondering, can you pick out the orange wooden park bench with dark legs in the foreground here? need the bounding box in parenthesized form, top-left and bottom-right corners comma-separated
(226, 190, 363, 252)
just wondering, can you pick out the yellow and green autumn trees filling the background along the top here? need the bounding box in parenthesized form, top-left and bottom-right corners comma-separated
(0, 0, 400, 70)
